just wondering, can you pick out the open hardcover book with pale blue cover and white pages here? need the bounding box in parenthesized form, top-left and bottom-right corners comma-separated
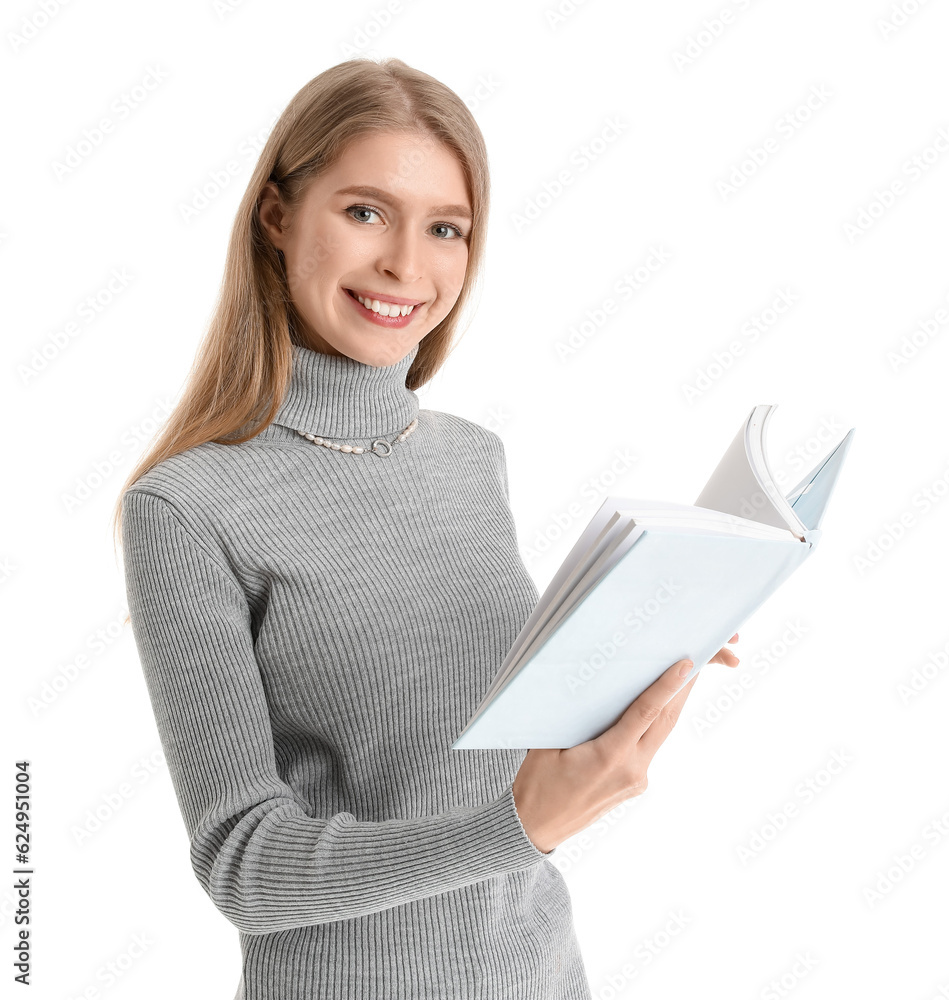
(451, 404, 854, 750)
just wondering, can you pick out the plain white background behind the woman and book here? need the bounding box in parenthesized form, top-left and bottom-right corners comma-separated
(0, 0, 949, 1000)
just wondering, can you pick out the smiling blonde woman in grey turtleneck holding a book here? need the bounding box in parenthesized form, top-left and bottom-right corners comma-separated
(113, 59, 737, 1000)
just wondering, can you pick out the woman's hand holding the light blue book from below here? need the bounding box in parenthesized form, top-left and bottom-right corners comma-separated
(513, 656, 700, 854)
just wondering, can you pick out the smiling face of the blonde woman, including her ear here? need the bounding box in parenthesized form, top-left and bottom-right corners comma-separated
(260, 133, 471, 367)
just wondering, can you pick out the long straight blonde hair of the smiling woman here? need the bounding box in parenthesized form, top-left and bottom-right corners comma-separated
(113, 57, 489, 556)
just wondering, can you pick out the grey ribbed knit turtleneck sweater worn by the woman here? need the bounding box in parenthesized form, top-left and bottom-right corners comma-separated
(122, 345, 591, 1000)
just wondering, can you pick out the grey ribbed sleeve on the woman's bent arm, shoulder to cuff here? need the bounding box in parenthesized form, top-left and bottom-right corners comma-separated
(122, 488, 548, 934)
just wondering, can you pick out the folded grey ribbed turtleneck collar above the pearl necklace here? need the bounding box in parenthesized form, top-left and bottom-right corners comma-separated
(273, 344, 419, 438)
